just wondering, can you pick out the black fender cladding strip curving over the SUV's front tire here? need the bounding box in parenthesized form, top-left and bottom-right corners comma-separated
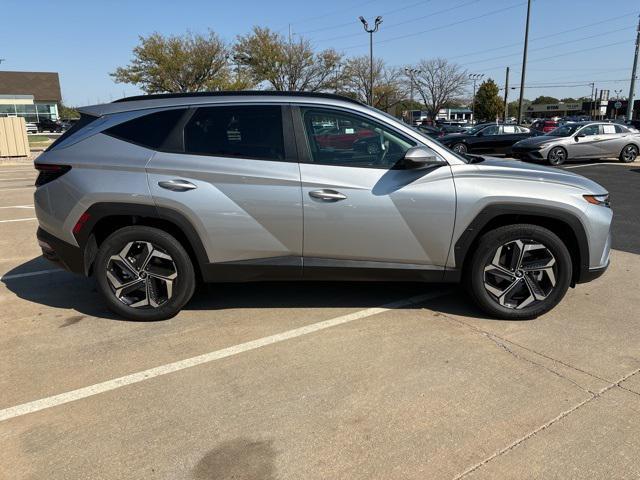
(454, 204, 589, 283)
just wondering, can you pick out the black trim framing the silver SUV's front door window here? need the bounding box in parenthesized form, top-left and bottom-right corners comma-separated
(292, 103, 420, 170)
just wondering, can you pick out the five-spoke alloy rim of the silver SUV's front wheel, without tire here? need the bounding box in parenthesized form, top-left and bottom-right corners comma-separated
(484, 239, 558, 310)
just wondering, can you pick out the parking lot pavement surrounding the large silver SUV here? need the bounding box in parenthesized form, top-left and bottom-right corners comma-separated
(0, 162, 640, 480)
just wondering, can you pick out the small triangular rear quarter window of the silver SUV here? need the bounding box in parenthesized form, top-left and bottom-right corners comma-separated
(105, 108, 185, 149)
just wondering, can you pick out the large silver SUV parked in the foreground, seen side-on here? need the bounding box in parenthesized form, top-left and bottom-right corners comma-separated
(35, 92, 612, 320)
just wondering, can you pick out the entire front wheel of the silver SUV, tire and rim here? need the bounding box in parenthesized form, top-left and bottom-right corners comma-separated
(466, 224, 572, 320)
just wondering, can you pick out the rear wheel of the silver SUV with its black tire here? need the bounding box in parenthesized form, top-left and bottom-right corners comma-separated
(93, 226, 196, 321)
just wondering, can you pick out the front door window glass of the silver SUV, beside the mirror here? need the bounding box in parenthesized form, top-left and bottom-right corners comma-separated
(302, 108, 416, 168)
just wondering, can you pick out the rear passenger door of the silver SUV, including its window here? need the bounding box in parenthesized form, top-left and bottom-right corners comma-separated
(147, 104, 302, 273)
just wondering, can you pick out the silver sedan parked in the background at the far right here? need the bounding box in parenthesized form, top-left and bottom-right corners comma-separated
(512, 122, 640, 165)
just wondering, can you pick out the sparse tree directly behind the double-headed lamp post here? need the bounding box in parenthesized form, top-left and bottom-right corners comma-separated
(338, 55, 406, 111)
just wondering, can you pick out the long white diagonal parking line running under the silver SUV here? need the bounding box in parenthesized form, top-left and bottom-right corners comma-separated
(0, 290, 449, 422)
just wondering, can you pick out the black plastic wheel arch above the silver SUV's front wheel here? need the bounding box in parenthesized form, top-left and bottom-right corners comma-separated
(454, 205, 589, 286)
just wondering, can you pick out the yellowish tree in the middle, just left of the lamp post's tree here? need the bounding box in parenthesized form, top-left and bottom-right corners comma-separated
(233, 27, 342, 92)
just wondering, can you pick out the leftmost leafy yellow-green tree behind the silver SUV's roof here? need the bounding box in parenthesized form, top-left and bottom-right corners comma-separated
(110, 31, 242, 93)
